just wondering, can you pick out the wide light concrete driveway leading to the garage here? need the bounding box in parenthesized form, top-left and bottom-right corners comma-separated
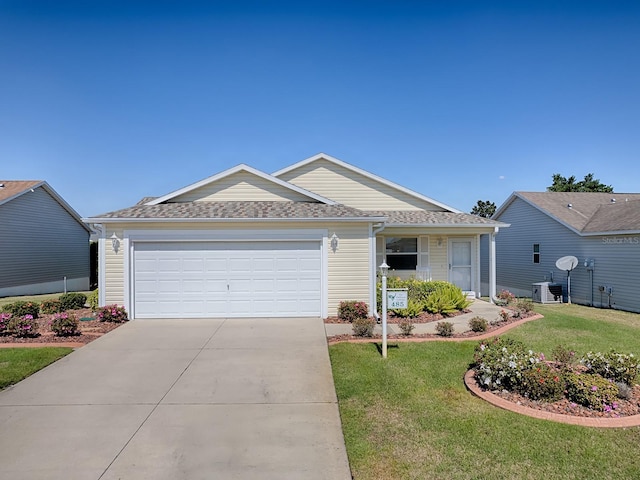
(0, 318, 351, 480)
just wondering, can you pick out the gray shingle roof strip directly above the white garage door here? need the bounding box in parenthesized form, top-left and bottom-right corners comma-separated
(87, 202, 376, 220)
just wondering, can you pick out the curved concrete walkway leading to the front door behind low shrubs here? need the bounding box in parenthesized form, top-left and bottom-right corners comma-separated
(324, 299, 503, 337)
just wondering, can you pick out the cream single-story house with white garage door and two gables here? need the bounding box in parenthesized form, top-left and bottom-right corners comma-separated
(85, 154, 507, 318)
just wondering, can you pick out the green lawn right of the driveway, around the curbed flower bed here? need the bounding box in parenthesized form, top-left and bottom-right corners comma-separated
(330, 305, 640, 480)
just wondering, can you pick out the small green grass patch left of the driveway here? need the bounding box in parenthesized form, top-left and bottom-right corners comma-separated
(0, 347, 73, 389)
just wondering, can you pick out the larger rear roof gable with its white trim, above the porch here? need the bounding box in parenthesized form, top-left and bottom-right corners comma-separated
(273, 153, 460, 213)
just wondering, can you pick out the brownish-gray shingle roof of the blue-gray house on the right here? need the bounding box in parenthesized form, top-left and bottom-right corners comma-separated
(515, 192, 640, 233)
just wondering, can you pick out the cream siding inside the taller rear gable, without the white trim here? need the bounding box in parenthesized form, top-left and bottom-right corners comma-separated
(279, 160, 443, 211)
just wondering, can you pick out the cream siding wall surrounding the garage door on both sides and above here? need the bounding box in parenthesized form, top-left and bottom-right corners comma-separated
(105, 222, 371, 316)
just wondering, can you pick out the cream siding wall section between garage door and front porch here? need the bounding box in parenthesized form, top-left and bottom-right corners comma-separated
(327, 224, 371, 316)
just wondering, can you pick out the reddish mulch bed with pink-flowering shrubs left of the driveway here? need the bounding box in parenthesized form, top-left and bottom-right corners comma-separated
(0, 308, 122, 344)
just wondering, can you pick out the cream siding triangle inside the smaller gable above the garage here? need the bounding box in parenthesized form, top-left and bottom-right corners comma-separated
(171, 172, 310, 202)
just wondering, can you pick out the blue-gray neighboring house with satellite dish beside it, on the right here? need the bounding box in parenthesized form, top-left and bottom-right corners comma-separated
(480, 192, 640, 312)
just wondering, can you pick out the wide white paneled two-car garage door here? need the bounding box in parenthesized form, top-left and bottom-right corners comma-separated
(133, 242, 321, 318)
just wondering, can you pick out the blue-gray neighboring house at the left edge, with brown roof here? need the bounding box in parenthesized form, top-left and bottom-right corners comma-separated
(0, 180, 90, 297)
